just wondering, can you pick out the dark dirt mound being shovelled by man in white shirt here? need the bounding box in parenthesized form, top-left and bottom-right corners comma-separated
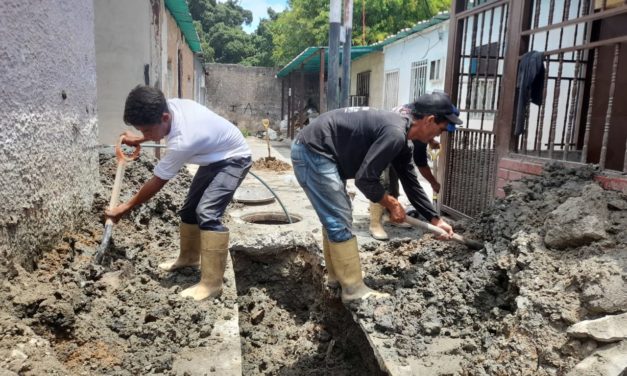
(0, 156, 236, 375)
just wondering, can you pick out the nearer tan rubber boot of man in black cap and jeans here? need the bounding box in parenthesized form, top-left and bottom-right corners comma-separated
(329, 236, 389, 303)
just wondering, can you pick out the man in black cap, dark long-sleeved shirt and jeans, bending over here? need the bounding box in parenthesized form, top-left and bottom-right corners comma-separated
(292, 93, 462, 302)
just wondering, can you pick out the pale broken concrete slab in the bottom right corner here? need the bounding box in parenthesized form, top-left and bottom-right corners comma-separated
(567, 341, 627, 376)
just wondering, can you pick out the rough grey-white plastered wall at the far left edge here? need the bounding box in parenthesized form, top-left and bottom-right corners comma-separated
(0, 0, 99, 275)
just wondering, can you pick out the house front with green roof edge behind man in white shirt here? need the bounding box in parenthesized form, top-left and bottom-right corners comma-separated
(94, 0, 204, 144)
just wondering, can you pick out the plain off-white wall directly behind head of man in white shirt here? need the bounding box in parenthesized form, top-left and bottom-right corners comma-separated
(94, 0, 167, 144)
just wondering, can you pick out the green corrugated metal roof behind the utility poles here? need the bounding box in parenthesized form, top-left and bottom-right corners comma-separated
(277, 12, 450, 77)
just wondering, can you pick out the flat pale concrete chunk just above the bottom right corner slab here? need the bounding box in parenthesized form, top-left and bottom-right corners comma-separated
(567, 313, 627, 342)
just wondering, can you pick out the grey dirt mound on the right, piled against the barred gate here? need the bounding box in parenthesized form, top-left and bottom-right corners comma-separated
(353, 165, 627, 375)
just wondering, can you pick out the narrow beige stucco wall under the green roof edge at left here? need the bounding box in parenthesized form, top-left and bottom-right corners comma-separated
(164, 11, 194, 99)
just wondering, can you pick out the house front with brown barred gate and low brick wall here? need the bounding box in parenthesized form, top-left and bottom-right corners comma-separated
(442, 0, 627, 216)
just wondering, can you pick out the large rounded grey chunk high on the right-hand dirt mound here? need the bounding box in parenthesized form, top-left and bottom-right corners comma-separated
(544, 185, 609, 249)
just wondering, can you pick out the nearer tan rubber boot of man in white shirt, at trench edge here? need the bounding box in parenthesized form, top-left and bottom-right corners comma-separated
(181, 230, 229, 300)
